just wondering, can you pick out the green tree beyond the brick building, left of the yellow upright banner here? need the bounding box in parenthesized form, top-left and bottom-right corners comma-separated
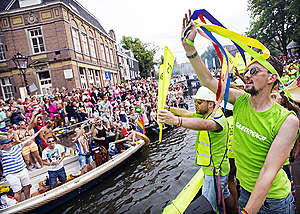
(121, 36, 157, 77)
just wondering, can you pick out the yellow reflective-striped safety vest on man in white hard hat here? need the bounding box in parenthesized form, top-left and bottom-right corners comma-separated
(194, 109, 223, 166)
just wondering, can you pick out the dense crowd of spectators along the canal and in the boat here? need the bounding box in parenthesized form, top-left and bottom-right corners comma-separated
(0, 77, 184, 205)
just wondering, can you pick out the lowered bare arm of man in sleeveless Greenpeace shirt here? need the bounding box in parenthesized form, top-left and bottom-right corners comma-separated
(245, 115, 299, 213)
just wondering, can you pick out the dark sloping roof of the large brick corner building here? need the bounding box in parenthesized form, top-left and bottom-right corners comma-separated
(0, 0, 107, 34)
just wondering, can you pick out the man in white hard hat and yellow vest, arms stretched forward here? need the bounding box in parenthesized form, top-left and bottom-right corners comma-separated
(158, 86, 233, 212)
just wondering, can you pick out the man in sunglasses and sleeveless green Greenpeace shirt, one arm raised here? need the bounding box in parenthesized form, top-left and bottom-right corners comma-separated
(182, 10, 299, 214)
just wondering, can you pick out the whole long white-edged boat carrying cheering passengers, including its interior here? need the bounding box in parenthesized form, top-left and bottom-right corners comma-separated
(0, 133, 150, 213)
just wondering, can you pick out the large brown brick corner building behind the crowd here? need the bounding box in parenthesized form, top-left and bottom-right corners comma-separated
(0, 0, 120, 99)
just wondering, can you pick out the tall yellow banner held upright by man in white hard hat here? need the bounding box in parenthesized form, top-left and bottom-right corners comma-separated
(157, 46, 174, 142)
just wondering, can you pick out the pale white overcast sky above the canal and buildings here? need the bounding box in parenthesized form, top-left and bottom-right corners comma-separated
(77, 0, 250, 63)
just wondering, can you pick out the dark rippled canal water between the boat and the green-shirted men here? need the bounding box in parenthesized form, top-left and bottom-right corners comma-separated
(55, 97, 198, 214)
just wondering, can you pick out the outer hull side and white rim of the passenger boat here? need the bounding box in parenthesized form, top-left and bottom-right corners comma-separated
(1, 140, 145, 213)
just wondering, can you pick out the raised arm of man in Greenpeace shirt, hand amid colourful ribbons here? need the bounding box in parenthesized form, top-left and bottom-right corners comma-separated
(182, 10, 243, 104)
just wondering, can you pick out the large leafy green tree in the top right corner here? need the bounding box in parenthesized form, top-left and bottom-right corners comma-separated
(246, 0, 300, 55)
